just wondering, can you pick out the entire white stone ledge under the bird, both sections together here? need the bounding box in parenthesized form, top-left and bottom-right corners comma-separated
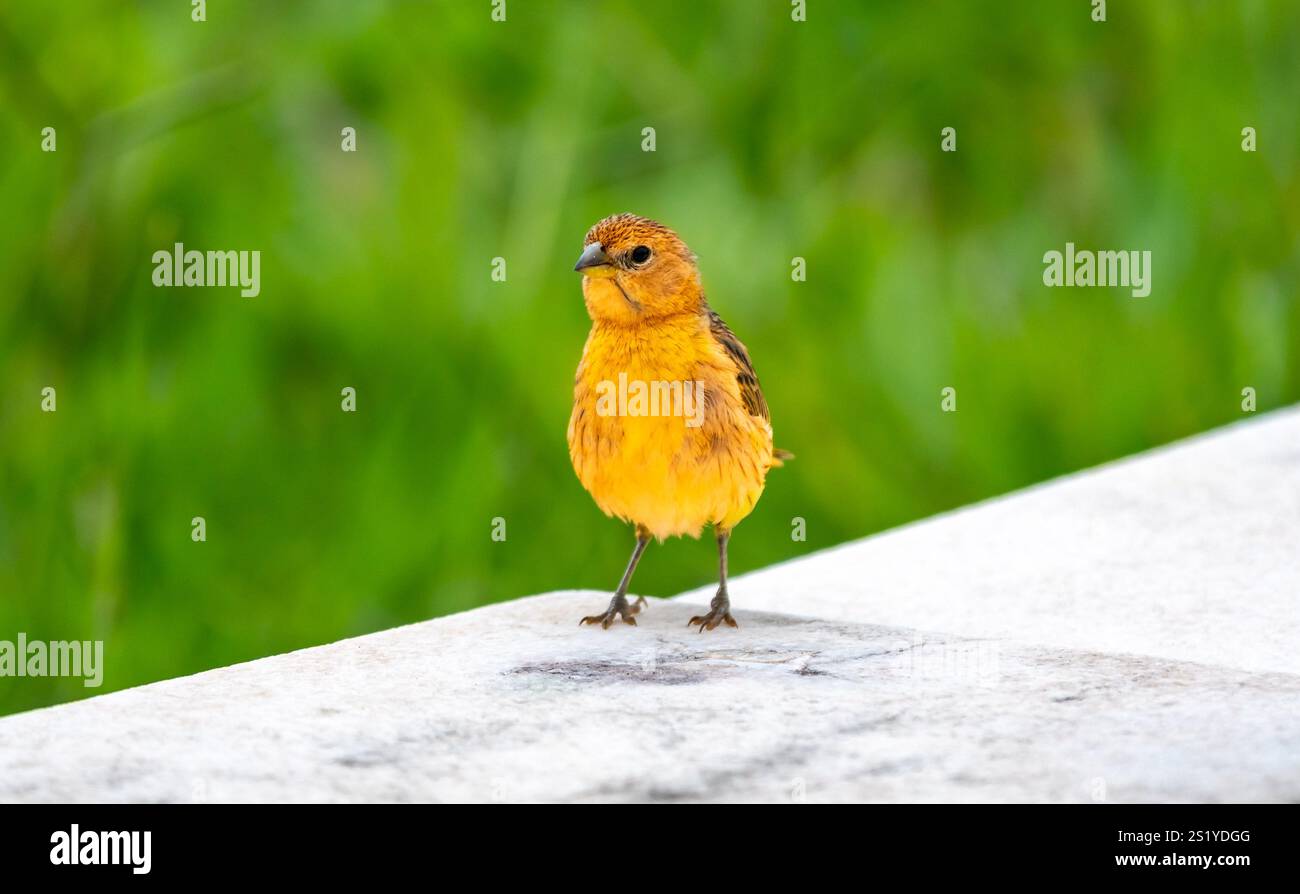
(0, 411, 1300, 802)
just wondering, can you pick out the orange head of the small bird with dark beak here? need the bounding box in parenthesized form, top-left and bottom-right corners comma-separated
(573, 214, 703, 325)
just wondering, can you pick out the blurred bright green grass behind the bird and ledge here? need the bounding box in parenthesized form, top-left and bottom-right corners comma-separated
(0, 0, 1300, 713)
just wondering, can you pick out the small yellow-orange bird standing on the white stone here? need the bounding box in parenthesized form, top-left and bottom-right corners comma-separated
(568, 214, 792, 632)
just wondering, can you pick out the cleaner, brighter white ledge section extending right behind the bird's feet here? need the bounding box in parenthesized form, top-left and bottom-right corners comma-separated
(684, 408, 1300, 673)
